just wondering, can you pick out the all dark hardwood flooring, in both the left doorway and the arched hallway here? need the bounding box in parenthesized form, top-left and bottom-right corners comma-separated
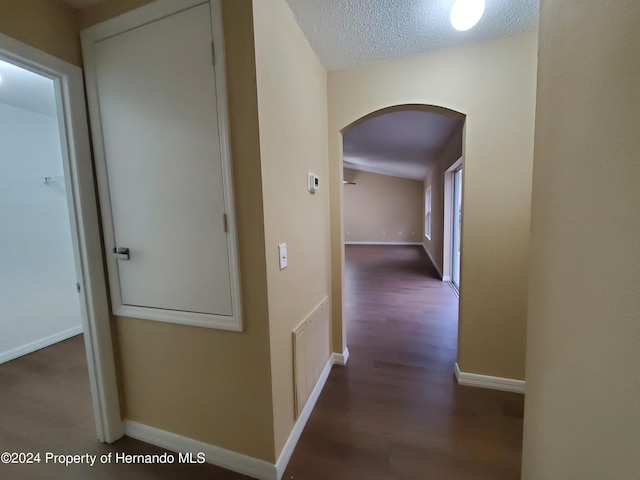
(0, 246, 523, 480)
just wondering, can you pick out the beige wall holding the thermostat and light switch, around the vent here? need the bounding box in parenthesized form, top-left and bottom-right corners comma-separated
(253, 0, 330, 453)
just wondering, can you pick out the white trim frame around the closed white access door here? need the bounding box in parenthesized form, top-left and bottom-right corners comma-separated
(80, 0, 243, 331)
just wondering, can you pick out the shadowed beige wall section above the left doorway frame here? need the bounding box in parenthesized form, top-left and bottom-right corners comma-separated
(0, 0, 82, 65)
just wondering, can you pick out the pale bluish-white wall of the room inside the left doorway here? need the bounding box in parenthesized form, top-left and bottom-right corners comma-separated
(0, 102, 82, 362)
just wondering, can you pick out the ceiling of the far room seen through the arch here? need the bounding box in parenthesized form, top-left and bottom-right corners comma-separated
(343, 110, 462, 180)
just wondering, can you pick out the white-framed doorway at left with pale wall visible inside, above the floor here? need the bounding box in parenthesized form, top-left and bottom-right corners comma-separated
(0, 34, 123, 442)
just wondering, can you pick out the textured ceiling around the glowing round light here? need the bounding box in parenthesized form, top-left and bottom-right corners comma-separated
(287, 0, 539, 70)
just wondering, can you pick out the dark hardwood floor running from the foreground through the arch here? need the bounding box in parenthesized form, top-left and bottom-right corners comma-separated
(283, 245, 524, 480)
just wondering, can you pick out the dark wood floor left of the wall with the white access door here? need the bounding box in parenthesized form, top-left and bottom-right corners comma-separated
(0, 335, 248, 480)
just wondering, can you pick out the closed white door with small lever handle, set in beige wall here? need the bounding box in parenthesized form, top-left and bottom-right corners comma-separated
(83, 2, 242, 329)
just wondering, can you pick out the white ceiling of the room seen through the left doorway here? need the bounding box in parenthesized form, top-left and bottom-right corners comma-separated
(0, 60, 56, 116)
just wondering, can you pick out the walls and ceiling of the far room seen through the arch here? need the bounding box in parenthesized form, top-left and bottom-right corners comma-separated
(341, 104, 465, 360)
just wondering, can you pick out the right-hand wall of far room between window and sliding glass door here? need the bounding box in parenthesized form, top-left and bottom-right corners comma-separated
(422, 125, 464, 273)
